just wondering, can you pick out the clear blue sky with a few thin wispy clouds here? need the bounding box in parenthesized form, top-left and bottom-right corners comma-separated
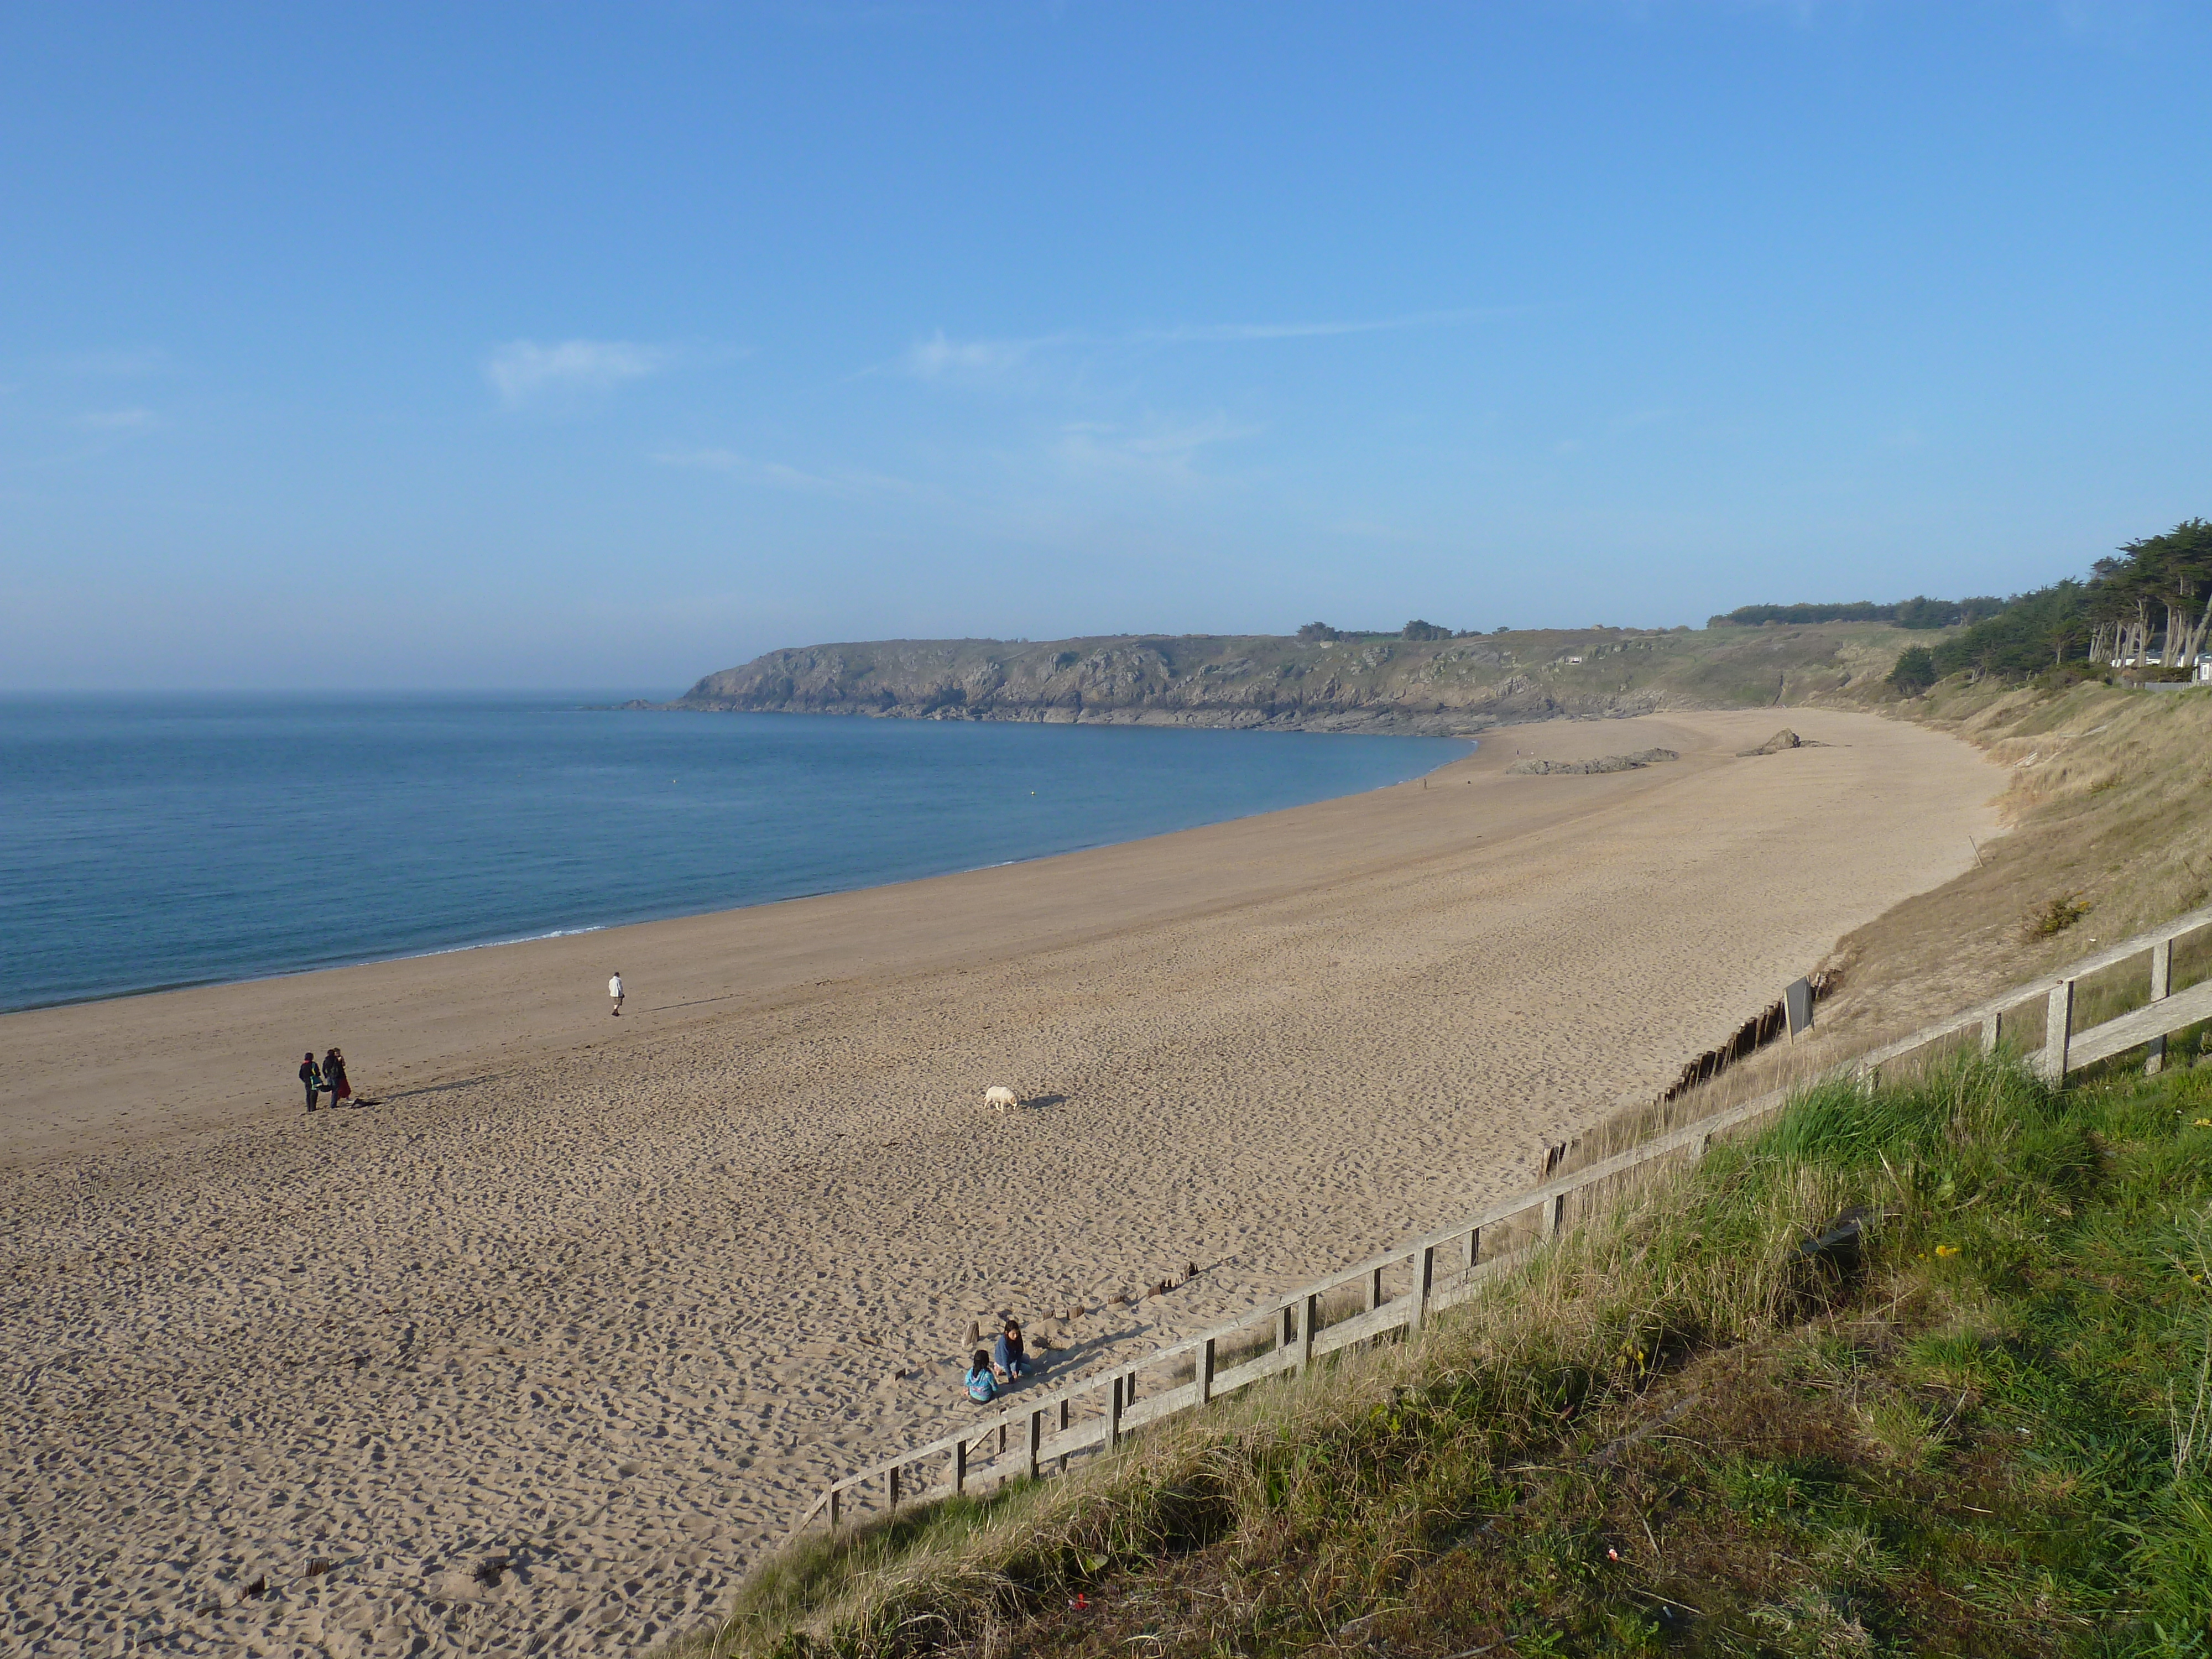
(0, 0, 2212, 688)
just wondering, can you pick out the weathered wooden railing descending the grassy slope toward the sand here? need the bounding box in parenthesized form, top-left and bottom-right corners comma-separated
(792, 907, 2212, 1531)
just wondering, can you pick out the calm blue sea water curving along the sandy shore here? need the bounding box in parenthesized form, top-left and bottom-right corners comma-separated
(0, 692, 1467, 1009)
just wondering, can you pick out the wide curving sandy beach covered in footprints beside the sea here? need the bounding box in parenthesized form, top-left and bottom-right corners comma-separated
(0, 710, 2002, 1655)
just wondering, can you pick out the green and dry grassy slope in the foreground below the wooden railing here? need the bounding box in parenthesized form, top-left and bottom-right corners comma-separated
(672, 1060, 2212, 1659)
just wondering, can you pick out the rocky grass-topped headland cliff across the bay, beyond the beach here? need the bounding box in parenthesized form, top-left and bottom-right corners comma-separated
(661, 624, 1911, 737)
